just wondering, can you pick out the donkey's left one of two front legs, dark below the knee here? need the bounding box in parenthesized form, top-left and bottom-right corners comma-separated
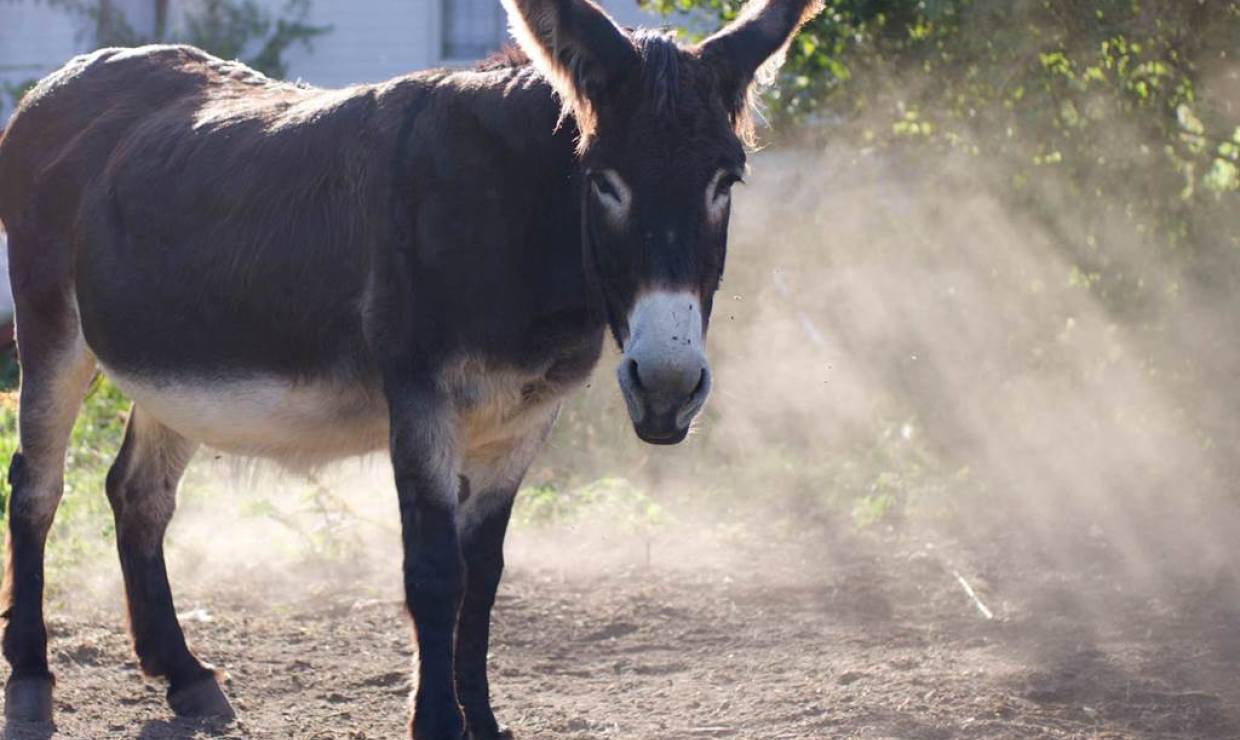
(388, 383, 465, 740)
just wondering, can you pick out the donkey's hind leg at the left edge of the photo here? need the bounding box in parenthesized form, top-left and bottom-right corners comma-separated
(2, 292, 94, 721)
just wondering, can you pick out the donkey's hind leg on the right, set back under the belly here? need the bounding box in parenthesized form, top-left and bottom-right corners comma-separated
(108, 405, 233, 716)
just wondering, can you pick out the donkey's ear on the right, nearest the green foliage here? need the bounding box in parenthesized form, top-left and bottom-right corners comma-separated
(697, 0, 822, 117)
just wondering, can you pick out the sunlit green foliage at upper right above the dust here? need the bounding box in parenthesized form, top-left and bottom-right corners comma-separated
(647, 0, 1240, 310)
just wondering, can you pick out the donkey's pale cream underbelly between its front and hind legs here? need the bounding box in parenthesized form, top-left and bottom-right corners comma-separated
(104, 368, 388, 467)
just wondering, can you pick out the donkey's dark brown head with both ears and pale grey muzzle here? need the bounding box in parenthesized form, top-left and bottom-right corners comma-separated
(505, 0, 820, 444)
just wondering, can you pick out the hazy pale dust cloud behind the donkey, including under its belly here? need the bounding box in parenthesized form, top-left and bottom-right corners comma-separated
(104, 130, 1240, 614)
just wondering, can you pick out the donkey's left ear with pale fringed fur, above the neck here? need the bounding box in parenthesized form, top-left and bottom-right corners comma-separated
(502, 0, 639, 127)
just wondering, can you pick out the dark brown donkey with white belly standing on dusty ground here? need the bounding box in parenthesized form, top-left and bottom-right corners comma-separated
(0, 0, 818, 739)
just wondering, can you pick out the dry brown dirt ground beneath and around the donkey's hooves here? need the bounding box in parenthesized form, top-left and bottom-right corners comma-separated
(5, 523, 1240, 739)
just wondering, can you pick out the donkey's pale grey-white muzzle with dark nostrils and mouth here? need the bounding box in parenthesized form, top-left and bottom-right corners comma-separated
(616, 293, 711, 445)
